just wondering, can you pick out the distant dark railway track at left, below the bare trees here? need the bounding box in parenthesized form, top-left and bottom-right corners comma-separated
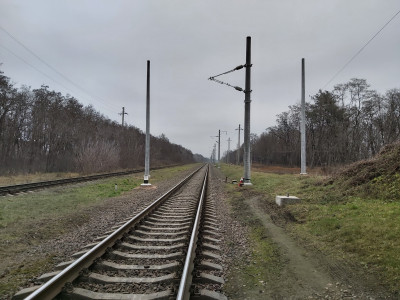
(0, 166, 178, 196)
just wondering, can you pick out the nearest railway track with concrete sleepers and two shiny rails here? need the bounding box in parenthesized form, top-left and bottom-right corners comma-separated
(13, 166, 226, 299)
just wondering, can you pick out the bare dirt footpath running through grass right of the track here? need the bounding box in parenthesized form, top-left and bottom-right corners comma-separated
(247, 197, 394, 300)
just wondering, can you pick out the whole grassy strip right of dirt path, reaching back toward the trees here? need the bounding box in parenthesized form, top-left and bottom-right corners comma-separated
(221, 165, 400, 292)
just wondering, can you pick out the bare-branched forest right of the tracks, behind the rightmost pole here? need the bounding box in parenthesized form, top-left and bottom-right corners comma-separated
(229, 78, 400, 167)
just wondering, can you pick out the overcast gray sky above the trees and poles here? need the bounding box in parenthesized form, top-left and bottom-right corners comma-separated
(0, 0, 400, 157)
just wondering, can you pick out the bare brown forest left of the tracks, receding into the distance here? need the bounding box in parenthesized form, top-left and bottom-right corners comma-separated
(0, 71, 194, 175)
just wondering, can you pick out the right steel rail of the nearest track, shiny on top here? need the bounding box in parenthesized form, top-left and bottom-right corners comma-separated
(176, 167, 208, 300)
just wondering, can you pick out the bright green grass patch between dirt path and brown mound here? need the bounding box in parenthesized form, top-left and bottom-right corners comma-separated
(291, 197, 400, 291)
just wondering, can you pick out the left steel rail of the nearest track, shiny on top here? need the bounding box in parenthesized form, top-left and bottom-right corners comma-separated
(25, 165, 204, 300)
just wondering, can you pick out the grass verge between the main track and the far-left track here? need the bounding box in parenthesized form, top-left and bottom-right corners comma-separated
(0, 165, 199, 299)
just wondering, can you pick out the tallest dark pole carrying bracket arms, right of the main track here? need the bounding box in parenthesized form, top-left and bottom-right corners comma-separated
(243, 36, 252, 185)
